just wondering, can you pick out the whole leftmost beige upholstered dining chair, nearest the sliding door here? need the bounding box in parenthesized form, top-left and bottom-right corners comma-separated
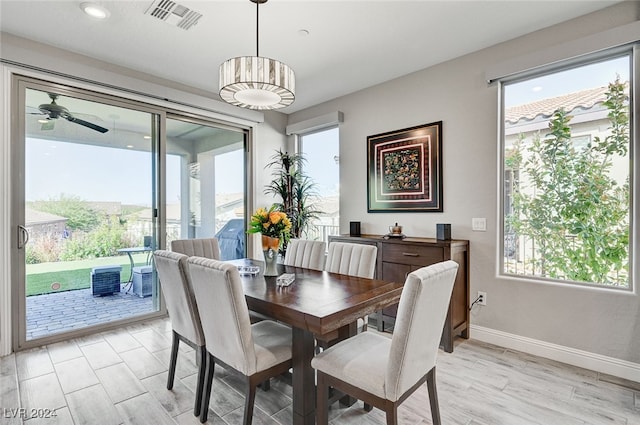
(153, 250, 207, 416)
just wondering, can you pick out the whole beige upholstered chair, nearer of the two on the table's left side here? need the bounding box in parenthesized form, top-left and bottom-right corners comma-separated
(188, 257, 292, 425)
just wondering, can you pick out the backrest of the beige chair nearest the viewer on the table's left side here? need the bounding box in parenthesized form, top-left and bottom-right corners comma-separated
(188, 257, 257, 375)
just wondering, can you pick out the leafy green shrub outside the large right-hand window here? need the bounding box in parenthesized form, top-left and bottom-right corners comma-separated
(507, 78, 629, 286)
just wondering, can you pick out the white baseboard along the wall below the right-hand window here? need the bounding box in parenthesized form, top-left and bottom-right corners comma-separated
(470, 325, 640, 382)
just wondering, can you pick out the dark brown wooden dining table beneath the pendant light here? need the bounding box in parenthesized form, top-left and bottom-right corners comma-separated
(230, 259, 404, 425)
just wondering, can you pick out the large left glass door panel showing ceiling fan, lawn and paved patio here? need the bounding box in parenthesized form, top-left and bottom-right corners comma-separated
(18, 84, 159, 343)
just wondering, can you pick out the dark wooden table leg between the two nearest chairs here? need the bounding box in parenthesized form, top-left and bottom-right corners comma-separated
(292, 328, 316, 425)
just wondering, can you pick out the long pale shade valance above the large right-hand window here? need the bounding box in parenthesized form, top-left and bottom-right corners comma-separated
(485, 21, 640, 84)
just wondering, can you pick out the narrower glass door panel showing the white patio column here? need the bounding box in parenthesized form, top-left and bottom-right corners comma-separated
(166, 118, 246, 260)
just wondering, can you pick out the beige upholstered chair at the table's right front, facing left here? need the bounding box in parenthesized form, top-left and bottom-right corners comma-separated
(311, 260, 458, 425)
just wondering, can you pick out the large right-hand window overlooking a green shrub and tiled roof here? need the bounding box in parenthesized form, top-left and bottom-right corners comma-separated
(501, 53, 633, 288)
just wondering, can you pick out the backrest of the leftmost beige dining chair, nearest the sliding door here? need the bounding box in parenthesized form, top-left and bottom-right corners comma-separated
(153, 250, 205, 346)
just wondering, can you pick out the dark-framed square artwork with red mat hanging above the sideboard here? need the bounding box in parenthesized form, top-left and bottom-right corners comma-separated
(367, 121, 442, 212)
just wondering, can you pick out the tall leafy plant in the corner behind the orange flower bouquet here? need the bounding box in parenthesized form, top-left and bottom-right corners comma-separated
(264, 150, 320, 243)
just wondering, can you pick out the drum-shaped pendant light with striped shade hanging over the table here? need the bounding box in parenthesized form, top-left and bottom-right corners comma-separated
(220, 0, 296, 109)
